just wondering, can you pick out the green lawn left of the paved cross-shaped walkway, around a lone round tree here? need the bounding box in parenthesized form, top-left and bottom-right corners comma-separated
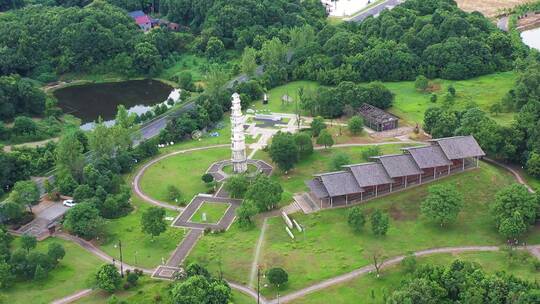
(98, 195, 184, 268)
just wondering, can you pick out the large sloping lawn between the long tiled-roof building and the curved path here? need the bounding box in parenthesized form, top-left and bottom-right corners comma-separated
(262, 163, 540, 293)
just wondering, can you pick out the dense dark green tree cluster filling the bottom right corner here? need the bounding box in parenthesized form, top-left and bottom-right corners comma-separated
(386, 260, 540, 304)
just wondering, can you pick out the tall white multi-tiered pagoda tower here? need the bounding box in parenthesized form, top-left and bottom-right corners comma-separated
(231, 93, 247, 173)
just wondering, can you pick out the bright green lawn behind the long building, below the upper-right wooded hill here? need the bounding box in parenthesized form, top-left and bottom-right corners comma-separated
(384, 72, 517, 126)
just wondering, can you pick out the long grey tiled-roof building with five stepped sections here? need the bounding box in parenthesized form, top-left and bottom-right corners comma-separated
(306, 136, 485, 208)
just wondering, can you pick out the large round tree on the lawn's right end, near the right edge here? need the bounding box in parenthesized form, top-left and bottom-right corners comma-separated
(490, 184, 539, 239)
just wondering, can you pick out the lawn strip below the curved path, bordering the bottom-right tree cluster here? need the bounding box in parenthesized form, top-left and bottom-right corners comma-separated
(291, 252, 538, 304)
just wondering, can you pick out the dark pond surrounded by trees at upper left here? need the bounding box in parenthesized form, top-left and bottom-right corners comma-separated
(53, 79, 173, 123)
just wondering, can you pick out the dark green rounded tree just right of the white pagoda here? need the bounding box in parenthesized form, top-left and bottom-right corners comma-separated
(269, 132, 298, 172)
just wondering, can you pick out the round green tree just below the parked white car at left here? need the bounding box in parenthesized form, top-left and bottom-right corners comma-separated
(64, 203, 103, 240)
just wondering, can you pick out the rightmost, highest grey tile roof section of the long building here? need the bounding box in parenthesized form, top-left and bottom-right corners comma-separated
(432, 135, 486, 159)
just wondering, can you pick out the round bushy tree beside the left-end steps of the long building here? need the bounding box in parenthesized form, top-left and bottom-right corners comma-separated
(245, 174, 283, 212)
